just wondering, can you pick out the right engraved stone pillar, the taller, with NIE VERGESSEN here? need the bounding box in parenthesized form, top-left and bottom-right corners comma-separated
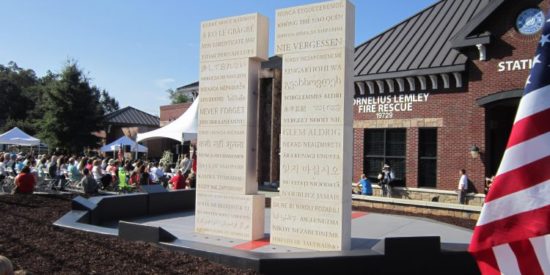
(271, 1, 355, 251)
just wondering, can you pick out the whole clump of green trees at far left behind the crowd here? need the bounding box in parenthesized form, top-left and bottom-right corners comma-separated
(0, 61, 119, 153)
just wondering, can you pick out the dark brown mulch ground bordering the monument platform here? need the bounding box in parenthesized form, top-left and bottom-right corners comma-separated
(0, 195, 475, 275)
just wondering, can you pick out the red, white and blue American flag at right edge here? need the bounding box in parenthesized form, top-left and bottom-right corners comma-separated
(469, 11, 550, 274)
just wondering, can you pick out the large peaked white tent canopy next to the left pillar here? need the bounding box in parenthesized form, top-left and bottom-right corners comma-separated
(137, 97, 199, 142)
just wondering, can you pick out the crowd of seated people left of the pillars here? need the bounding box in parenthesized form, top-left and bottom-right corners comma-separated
(0, 152, 197, 194)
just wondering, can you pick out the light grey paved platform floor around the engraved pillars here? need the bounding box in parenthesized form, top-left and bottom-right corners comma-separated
(132, 209, 472, 254)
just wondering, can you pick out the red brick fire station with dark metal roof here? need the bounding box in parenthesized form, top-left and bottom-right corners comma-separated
(353, 0, 548, 192)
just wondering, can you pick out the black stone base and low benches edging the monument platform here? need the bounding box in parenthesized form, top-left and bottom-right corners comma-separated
(55, 190, 479, 274)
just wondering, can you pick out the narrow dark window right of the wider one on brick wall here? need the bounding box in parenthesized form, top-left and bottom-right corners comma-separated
(418, 128, 437, 188)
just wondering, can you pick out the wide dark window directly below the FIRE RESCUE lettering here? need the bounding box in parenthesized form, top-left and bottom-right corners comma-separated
(363, 129, 406, 186)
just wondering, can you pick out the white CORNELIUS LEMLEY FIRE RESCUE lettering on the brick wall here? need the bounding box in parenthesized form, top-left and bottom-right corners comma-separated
(353, 93, 430, 118)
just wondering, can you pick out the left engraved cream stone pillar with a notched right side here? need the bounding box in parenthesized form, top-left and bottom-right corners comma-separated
(195, 14, 268, 240)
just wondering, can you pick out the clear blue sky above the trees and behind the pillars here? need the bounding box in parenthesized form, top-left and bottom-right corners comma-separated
(0, 0, 437, 116)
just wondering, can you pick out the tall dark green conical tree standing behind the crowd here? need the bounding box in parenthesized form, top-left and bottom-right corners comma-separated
(38, 61, 104, 153)
